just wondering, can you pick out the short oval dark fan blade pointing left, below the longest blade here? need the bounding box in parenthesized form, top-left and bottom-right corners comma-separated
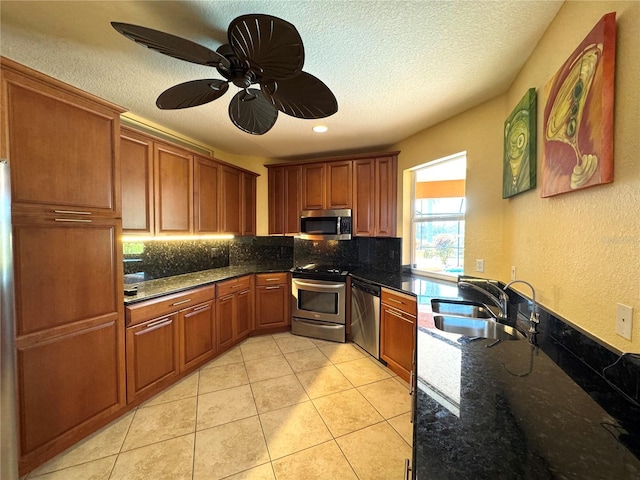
(156, 78, 229, 110)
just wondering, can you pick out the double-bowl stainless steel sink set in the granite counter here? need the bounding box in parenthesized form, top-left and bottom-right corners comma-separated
(431, 299, 525, 340)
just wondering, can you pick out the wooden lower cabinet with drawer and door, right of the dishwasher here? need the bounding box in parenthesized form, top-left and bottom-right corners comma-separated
(380, 289, 417, 382)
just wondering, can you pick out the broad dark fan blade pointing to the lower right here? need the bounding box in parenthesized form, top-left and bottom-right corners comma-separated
(262, 72, 338, 119)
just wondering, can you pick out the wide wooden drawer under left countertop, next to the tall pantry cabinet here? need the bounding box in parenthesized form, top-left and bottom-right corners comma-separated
(125, 285, 215, 326)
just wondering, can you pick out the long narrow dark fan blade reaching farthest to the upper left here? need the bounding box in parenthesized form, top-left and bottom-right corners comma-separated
(111, 22, 231, 69)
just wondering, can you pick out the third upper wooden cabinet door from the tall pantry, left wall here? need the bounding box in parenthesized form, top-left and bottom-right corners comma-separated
(193, 156, 221, 234)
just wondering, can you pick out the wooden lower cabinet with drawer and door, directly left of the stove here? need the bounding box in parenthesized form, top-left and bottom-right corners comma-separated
(255, 273, 291, 331)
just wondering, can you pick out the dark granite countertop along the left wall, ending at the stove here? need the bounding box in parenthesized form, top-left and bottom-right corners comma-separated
(124, 264, 291, 305)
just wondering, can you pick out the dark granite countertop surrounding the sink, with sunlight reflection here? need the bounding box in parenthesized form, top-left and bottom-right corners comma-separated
(353, 270, 640, 480)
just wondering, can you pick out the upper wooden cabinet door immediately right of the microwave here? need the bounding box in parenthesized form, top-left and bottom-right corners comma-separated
(352, 158, 376, 237)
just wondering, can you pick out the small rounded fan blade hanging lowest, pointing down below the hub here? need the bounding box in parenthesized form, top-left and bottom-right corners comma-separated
(229, 88, 278, 135)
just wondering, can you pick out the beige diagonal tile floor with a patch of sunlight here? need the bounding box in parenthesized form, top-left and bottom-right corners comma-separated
(27, 333, 412, 480)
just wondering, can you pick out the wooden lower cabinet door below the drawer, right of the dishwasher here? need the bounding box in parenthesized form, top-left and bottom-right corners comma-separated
(380, 304, 416, 382)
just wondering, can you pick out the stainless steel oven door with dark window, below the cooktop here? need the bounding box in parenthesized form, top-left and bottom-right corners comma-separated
(291, 278, 346, 325)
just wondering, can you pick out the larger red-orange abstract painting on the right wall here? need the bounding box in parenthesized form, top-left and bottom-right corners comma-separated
(542, 12, 616, 197)
